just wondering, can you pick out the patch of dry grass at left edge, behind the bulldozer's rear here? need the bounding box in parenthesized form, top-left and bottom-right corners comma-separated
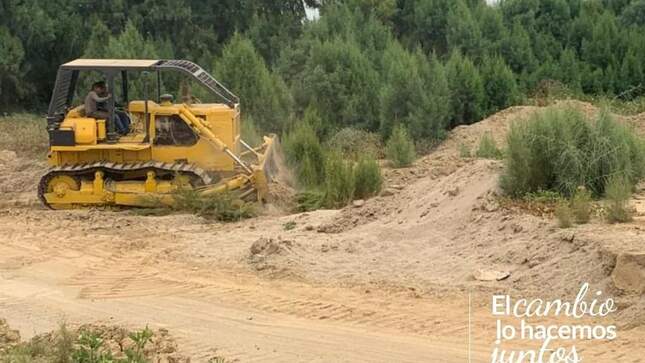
(0, 113, 49, 157)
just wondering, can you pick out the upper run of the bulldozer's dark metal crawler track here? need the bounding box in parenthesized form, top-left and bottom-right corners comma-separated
(38, 161, 213, 208)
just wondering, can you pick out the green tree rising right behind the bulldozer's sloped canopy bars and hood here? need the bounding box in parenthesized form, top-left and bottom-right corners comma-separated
(213, 34, 292, 131)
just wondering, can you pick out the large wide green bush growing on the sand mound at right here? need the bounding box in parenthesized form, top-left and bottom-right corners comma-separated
(501, 106, 645, 197)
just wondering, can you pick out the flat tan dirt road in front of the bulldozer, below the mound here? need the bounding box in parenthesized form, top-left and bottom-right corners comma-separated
(0, 209, 645, 362)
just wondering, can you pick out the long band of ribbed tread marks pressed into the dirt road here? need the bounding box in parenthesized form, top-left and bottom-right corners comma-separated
(67, 250, 467, 337)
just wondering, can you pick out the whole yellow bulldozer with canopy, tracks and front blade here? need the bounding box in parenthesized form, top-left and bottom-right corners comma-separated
(38, 59, 275, 209)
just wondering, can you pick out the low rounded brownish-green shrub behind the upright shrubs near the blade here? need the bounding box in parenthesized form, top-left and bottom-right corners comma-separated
(327, 127, 383, 160)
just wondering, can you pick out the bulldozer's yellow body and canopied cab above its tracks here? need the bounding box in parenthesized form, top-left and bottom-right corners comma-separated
(47, 59, 247, 171)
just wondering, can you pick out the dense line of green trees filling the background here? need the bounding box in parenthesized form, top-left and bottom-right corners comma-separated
(0, 0, 645, 141)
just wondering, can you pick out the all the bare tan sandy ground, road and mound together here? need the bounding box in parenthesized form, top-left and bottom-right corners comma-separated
(0, 104, 645, 362)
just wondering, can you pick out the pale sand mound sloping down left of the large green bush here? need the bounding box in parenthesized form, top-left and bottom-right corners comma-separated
(248, 101, 642, 304)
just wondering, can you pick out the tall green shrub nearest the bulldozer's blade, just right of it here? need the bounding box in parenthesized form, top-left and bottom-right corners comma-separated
(283, 122, 325, 188)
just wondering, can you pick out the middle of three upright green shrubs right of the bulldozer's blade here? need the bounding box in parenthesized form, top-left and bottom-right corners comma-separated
(325, 151, 354, 208)
